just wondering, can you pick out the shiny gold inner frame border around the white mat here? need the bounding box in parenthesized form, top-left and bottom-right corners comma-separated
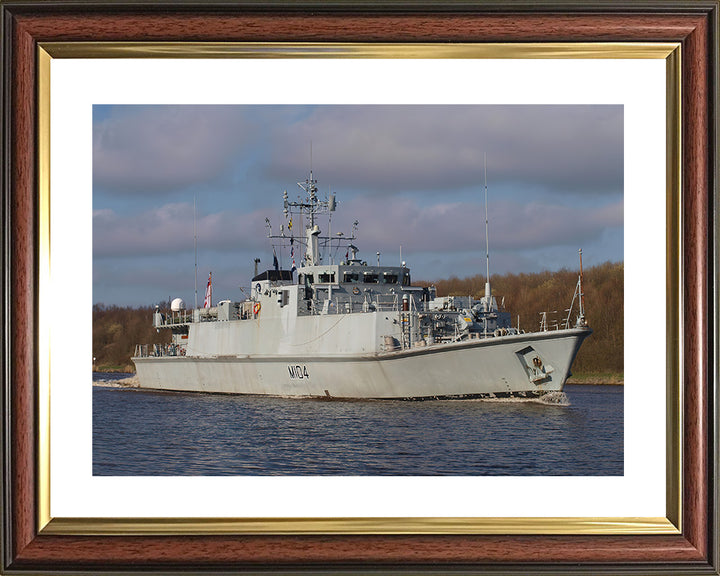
(37, 42, 683, 535)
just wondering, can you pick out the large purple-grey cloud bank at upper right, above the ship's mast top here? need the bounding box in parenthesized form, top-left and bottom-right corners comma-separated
(265, 106, 623, 193)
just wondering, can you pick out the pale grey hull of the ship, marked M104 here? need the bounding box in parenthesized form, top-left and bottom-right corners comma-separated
(133, 328, 591, 399)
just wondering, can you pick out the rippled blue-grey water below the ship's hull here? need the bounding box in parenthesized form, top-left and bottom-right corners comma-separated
(93, 375, 624, 476)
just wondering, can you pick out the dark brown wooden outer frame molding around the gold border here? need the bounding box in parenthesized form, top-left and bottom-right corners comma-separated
(0, 0, 720, 574)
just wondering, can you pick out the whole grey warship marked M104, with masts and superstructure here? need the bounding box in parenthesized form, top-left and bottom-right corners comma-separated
(132, 170, 592, 400)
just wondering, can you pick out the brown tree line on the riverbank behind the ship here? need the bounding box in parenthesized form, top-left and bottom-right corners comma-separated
(93, 262, 624, 375)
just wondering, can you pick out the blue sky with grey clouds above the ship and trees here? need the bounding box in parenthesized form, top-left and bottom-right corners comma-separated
(93, 105, 623, 305)
